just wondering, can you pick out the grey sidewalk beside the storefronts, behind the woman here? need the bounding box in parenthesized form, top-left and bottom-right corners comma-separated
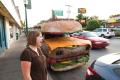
(0, 34, 52, 80)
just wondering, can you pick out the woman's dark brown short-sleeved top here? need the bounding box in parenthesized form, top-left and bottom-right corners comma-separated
(20, 47, 47, 80)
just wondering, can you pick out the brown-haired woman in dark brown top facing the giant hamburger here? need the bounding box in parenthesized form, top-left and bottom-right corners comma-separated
(20, 31, 47, 80)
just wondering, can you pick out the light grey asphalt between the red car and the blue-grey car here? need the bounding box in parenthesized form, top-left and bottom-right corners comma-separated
(88, 38, 120, 64)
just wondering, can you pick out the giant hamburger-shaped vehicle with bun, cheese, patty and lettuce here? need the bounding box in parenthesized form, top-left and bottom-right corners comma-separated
(41, 20, 91, 71)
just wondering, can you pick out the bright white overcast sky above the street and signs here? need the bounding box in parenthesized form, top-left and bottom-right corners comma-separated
(15, 0, 120, 27)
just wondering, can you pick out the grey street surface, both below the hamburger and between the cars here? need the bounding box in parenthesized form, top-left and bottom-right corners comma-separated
(49, 38, 120, 80)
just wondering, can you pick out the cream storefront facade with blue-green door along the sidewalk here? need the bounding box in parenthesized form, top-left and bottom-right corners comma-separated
(0, 0, 22, 54)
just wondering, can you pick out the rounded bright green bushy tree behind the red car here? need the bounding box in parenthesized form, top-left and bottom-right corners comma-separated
(86, 19, 100, 31)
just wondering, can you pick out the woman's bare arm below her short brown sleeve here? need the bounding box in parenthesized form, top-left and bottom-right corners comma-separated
(21, 61, 32, 80)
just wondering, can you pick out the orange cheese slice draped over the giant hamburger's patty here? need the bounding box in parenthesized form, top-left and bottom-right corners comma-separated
(44, 37, 91, 50)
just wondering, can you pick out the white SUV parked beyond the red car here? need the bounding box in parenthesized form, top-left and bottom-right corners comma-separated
(94, 28, 115, 38)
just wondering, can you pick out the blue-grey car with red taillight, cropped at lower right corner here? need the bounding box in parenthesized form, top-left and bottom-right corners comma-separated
(86, 53, 120, 80)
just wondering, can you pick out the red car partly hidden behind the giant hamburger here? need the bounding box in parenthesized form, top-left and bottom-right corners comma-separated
(71, 31, 109, 48)
